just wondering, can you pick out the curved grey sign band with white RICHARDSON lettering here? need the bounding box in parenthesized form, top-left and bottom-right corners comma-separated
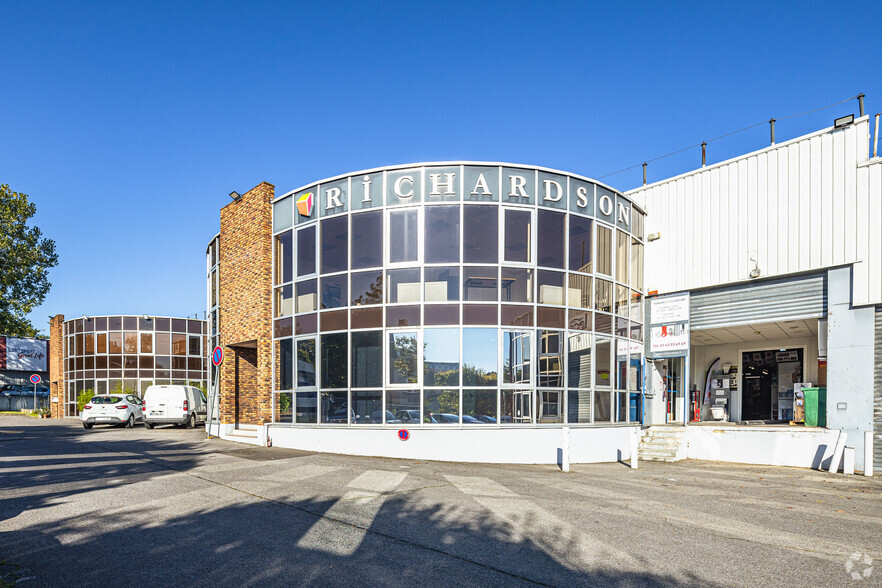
(275, 163, 632, 231)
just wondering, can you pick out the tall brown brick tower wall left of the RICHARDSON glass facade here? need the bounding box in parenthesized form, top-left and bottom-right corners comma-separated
(218, 182, 275, 424)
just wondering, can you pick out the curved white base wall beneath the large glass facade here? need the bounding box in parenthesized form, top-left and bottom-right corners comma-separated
(268, 425, 640, 464)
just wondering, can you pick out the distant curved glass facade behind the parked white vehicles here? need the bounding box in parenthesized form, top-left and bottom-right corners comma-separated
(64, 315, 207, 416)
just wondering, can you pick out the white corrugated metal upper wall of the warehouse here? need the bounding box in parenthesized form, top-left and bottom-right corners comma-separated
(626, 117, 882, 306)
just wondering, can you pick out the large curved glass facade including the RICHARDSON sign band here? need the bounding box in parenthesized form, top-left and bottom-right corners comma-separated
(272, 163, 644, 428)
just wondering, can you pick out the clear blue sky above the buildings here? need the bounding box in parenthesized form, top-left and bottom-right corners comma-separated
(0, 1, 882, 330)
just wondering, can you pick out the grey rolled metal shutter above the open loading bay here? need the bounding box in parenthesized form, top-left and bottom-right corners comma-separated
(689, 273, 827, 329)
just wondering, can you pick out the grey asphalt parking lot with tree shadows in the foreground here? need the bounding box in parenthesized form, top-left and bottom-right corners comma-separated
(0, 416, 882, 586)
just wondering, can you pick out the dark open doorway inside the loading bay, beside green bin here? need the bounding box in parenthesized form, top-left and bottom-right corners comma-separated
(741, 349, 803, 421)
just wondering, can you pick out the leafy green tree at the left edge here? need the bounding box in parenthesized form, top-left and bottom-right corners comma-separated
(0, 184, 58, 337)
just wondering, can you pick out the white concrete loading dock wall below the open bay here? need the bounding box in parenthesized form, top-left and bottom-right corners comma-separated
(686, 425, 839, 468)
